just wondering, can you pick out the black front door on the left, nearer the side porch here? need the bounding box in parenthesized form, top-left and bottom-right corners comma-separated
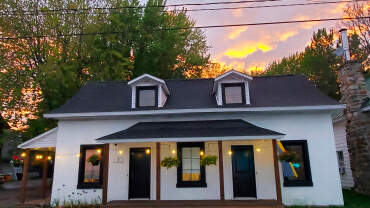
(129, 148, 150, 198)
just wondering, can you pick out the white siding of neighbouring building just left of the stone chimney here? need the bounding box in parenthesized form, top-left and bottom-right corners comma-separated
(333, 120, 354, 188)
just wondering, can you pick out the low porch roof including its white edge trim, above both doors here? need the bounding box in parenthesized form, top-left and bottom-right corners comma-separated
(97, 119, 284, 143)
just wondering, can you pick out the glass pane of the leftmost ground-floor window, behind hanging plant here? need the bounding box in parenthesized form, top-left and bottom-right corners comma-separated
(84, 149, 101, 183)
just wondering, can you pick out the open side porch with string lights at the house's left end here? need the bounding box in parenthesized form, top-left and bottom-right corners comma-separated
(17, 128, 57, 207)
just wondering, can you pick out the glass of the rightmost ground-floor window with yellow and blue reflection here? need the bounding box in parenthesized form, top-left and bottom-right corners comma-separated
(284, 145, 306, 180)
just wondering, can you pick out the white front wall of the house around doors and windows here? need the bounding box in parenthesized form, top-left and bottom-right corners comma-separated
(52, 112, 343, 205)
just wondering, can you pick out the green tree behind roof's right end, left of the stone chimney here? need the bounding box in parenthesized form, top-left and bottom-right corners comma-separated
(264, 29, 341, 99)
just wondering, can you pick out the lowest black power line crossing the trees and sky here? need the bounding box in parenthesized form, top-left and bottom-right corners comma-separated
(0, 16, 370, 40)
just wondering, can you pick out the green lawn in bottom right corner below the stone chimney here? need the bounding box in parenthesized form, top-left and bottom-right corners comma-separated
(289, 190, 370, 208)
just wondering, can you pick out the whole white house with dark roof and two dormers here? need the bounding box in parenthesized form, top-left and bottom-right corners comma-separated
(18, 71, 344, 206)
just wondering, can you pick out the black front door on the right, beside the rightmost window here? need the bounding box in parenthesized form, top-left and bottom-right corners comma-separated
(231, 145, 257, 197)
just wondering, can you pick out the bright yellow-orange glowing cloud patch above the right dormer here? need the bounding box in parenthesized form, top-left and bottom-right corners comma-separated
(224, 42, 273, 58)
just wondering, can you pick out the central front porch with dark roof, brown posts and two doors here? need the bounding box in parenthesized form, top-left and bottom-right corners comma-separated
(97, 120, 284, 207)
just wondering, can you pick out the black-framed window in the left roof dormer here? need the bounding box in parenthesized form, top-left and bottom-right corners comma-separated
(136, 86, 158, 108)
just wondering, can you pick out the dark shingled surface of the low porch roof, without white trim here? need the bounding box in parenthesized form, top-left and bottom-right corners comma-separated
(97, 119, 284, 140)
